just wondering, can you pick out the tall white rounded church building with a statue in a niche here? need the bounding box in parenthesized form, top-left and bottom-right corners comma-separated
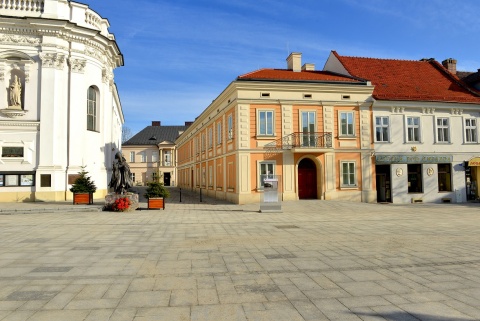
(0, 0, 124, 202)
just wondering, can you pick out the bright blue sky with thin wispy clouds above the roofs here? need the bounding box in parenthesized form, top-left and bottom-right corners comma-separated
(87, 0, 480, 134)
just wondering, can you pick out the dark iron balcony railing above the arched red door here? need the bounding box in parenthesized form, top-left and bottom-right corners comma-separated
(264, 133, 333, 152)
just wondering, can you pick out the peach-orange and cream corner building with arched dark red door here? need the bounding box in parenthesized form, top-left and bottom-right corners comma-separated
(176, 53, 376, 204)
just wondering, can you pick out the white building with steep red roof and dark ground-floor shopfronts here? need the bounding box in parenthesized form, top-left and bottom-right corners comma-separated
(324, 52, 480, 203)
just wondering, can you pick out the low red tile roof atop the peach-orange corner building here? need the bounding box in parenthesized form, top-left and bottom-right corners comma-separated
(237, 68, 362, 83)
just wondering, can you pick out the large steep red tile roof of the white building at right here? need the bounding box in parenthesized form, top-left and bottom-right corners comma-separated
(333, 51, 480, 104)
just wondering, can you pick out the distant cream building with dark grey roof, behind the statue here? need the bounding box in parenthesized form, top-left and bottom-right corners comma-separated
(122, 121, 191, 186)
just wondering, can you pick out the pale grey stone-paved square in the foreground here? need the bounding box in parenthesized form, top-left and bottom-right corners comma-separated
(0, 190, 480, 321)
